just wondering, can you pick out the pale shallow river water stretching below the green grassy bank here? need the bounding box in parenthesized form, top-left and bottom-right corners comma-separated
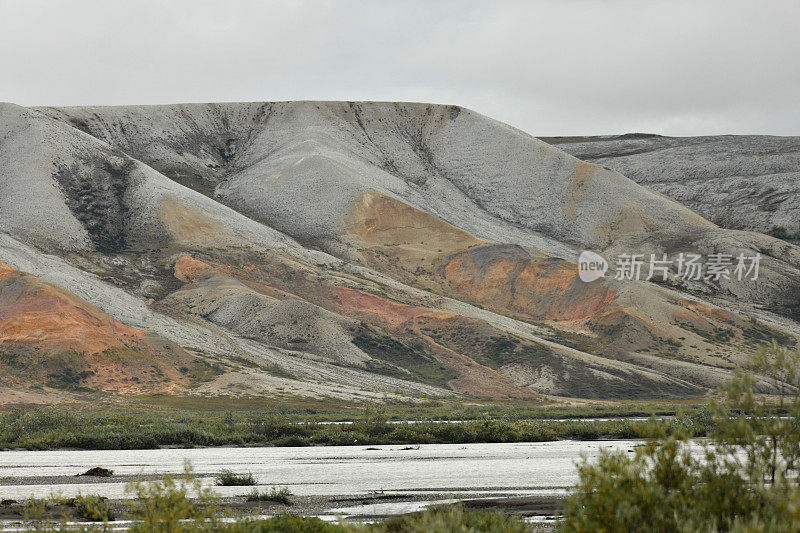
(0, 440, 639, 499)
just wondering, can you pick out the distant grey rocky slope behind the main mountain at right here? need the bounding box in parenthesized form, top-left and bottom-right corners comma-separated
(544, 134, 800, 240)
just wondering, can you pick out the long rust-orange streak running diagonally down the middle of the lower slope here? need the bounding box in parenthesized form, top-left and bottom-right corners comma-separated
(167, 249, 538, 400)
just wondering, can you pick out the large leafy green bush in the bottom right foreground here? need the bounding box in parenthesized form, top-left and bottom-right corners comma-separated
(560, 343, 800, 533)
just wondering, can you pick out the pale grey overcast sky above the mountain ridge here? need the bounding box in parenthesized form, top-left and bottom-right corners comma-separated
(0, 0, 800, 135)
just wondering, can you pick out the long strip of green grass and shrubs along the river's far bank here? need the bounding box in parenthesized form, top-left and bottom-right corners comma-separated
(0, 407, 709, 450)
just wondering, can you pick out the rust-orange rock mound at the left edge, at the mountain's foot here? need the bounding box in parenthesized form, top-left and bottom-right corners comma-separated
(0, 263, 189, 392)
